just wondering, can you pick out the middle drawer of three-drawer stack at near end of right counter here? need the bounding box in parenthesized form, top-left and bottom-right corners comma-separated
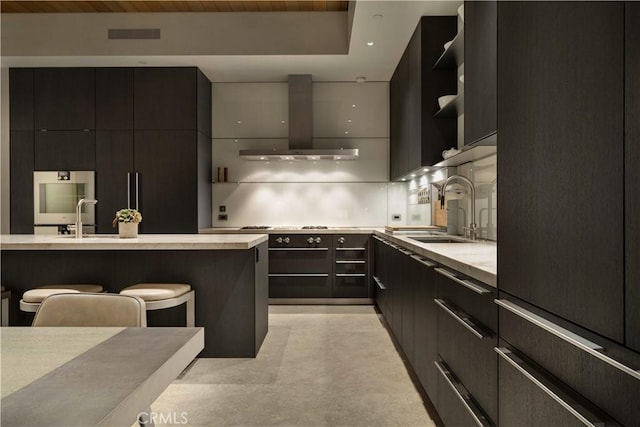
(434, 298, 498, 425)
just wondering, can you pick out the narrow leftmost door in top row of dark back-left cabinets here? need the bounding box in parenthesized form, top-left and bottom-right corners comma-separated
(9, 68, 33, 131)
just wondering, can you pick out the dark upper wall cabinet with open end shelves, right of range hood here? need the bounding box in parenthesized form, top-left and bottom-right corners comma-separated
(389, 16, 457, 180)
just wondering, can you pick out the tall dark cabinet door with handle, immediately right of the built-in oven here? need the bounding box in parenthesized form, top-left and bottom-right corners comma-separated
(96, 131, 133, 233)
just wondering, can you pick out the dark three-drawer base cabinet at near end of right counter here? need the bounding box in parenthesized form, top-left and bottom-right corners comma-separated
(434, 267, 498, 426)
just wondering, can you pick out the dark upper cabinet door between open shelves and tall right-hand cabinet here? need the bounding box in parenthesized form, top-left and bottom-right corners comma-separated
(464, 1, 498, 145)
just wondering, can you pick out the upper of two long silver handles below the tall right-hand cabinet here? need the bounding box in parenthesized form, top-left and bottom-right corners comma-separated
(494, 299, 640, 380)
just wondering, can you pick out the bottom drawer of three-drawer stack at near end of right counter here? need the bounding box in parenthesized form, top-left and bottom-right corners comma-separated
(434, 360, 494, 427)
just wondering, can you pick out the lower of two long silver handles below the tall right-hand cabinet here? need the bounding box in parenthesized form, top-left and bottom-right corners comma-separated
(494, 347, 605, 427)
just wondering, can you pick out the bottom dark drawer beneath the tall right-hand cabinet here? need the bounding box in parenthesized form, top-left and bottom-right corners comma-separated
(496, 346, 616, 427)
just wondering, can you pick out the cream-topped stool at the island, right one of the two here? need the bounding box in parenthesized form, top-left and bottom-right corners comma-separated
(120, 283, 196, 327)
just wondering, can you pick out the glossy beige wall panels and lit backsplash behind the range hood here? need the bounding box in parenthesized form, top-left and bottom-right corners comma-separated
(212, 82, 392, 227)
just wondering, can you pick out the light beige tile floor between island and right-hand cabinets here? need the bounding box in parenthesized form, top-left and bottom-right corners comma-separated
(152, 306, 435, 427)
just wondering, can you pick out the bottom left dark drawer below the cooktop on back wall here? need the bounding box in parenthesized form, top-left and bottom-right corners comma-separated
(269, 273, 331, 298)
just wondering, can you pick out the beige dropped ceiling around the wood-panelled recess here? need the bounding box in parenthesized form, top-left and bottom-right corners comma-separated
(0, 0, 462, 82)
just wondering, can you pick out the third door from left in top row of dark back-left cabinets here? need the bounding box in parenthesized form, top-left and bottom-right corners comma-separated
(96, 68, 133, 129)
